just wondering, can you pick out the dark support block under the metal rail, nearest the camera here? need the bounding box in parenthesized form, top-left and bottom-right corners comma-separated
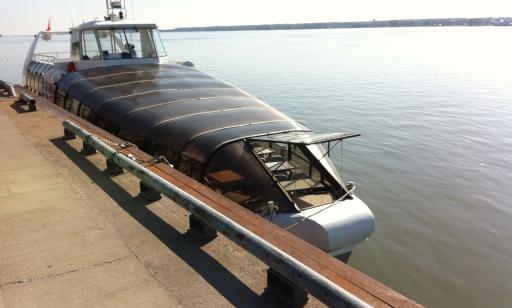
(265, 268, 309, 307)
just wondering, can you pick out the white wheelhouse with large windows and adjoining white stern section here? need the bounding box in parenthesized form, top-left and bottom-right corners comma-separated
(23, 20, 169, 98)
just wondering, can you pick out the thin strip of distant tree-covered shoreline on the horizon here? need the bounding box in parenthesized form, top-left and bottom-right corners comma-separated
(161, 17, 512, 32)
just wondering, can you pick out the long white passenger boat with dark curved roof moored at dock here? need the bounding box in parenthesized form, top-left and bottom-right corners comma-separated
(23, 0, 375, 262)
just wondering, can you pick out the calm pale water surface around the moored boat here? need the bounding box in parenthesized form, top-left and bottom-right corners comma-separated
(0, 27, 512, 307)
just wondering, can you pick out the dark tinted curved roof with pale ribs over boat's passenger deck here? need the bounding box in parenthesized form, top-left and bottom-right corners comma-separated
(59, 64, 309, 163)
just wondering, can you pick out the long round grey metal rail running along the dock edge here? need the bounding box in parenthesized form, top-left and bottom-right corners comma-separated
(63, 120, 370, 307)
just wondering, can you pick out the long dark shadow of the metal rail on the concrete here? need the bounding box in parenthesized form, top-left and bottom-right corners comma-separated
(50, 138, 279, 307)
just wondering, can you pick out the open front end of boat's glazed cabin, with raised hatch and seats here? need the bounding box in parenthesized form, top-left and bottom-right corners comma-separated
(204, 132, 356, 212)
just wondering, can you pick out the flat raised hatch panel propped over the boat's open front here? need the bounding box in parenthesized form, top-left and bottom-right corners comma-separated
(251, 132, 361, 145)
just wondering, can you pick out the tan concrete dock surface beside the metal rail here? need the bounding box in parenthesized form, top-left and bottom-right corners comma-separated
(0, 97, 322, 308)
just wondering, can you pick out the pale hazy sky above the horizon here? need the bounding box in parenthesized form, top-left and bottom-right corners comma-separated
(0, 0, 512, 34)
